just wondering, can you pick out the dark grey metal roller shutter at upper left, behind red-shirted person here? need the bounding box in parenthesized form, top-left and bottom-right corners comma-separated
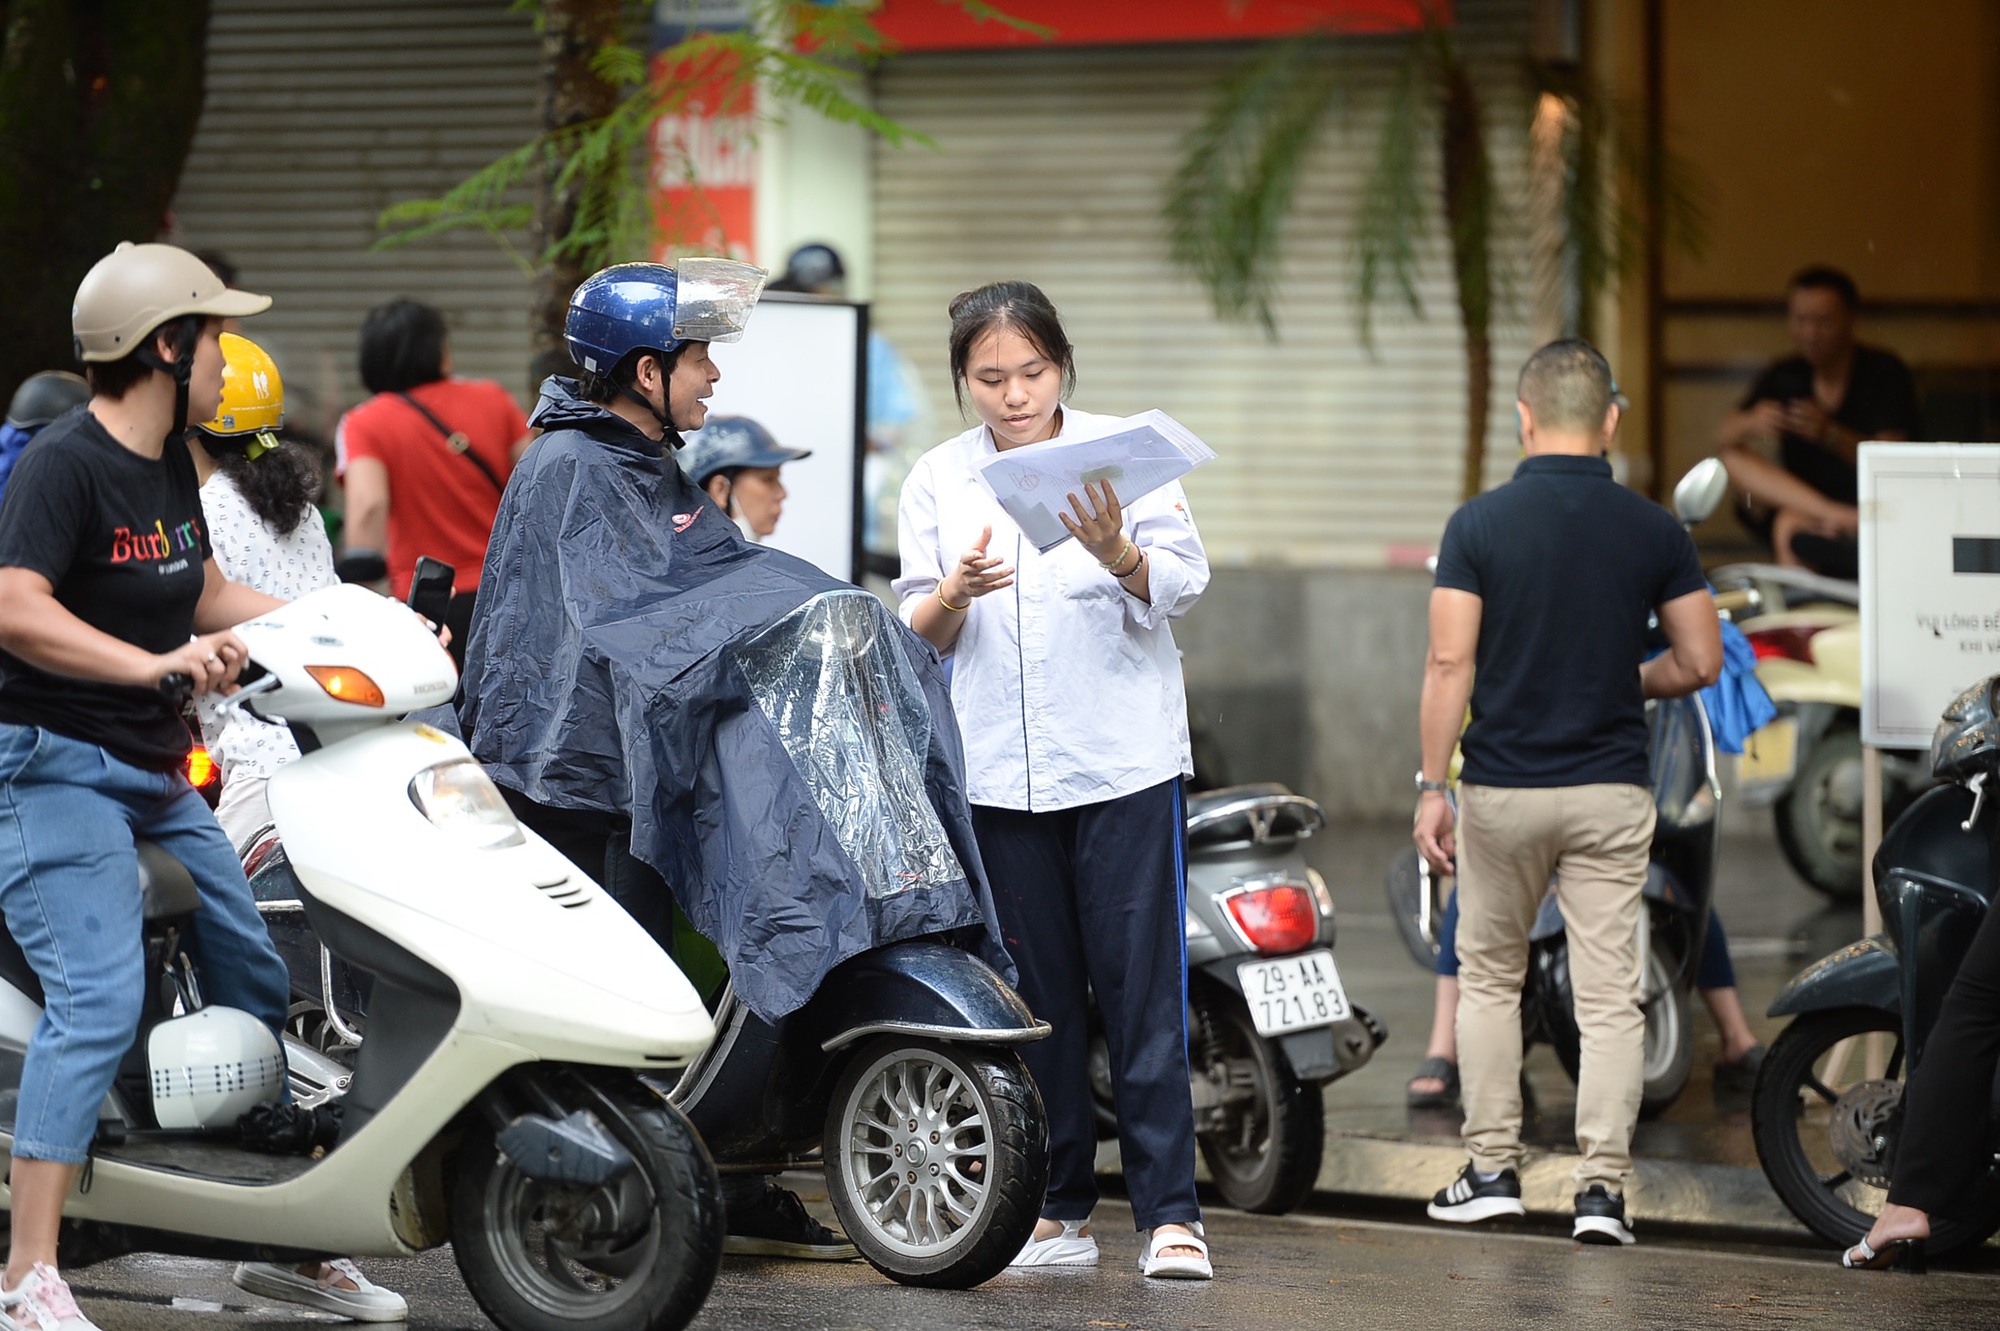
(174, 0, 540, 440)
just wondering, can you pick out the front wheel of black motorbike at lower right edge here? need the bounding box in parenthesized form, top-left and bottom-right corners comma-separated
(1750, 1007, 2000, 1257)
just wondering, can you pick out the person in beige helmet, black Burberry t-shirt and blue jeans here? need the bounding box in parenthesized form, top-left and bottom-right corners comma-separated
(0, 244, 288, 1331)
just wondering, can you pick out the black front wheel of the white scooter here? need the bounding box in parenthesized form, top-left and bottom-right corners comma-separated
(452, 1073, 724, 1331)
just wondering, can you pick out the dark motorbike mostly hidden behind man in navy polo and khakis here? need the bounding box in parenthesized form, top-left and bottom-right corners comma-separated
(1388, 458, 1728, 1117)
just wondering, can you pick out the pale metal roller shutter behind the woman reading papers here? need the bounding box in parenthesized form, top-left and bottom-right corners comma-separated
(874, 0, 1530, 568)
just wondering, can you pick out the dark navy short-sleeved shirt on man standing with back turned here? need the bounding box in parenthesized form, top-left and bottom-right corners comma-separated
(1438, 454, 1708, 787)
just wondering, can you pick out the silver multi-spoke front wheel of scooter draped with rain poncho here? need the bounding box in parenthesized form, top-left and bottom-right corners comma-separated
(824, 1035, 1048, 1289)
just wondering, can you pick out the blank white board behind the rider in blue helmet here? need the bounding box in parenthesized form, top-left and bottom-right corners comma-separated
(708, 294, 868, 582)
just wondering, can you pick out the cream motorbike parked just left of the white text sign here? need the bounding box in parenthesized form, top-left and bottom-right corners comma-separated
(1712, 564, 1928, 899)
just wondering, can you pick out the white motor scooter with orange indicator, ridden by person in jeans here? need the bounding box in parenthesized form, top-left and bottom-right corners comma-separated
(0, 586, 722, 1331)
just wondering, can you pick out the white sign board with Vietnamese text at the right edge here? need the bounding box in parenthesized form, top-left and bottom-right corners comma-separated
(1860, 444, 2000, 749)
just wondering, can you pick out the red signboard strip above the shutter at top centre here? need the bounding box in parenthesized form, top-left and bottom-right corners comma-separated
(874, 0, 1452, 50)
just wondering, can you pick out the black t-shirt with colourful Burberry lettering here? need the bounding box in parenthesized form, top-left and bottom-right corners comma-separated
(0, 410, 210, 771)
